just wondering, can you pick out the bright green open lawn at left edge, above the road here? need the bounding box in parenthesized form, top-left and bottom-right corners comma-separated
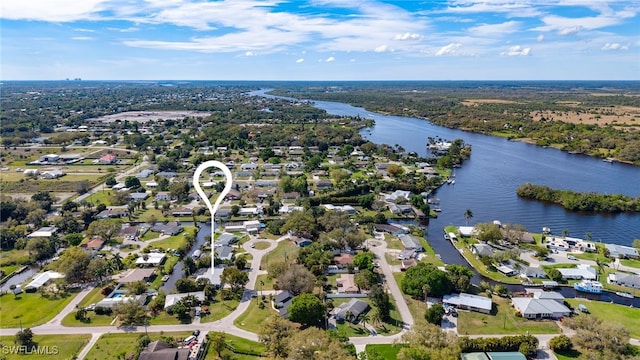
(0, 293, 76, 328)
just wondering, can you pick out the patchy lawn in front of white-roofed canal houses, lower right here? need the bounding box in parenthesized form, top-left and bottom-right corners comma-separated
(458, 296, 560, 335)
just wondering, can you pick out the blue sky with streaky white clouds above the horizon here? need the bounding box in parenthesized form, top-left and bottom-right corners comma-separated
(0, 0, 640, 80)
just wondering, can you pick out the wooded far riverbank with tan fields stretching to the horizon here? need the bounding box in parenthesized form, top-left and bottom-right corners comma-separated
(270, 81, 640, 166)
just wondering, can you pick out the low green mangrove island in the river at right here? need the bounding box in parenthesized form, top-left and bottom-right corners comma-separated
(516, 183, 640, 213)
